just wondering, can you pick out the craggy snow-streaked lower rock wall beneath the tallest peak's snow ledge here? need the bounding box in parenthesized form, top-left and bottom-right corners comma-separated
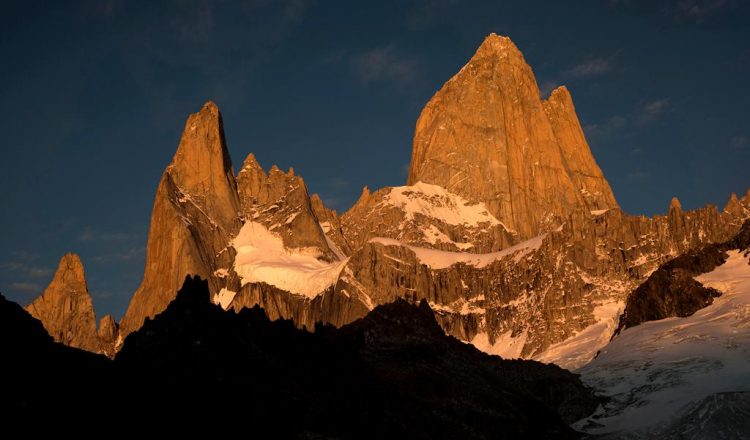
(340, 200, 750, 367)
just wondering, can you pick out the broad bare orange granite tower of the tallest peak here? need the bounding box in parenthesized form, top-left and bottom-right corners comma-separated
(408, 34, 618, 240)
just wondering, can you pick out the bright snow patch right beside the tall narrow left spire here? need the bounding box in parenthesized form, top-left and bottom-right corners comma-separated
(231, 221, 348, 298)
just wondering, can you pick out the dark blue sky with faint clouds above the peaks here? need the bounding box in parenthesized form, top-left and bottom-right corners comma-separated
(0, 0, 750, 318)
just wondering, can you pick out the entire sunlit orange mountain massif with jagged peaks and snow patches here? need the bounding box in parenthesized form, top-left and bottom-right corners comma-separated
(10, 34, 750, 432)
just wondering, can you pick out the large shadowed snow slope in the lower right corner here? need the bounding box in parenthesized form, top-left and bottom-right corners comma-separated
(577, 250, 750, 438)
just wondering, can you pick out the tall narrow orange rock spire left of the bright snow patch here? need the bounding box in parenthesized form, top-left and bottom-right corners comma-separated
(120, 102, 240, 336)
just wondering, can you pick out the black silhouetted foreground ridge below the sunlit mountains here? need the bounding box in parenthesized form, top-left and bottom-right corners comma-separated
(0, 278, 598, 438)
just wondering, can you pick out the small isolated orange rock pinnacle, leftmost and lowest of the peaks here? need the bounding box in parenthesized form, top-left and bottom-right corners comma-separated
(26, 254, 101, 352)
